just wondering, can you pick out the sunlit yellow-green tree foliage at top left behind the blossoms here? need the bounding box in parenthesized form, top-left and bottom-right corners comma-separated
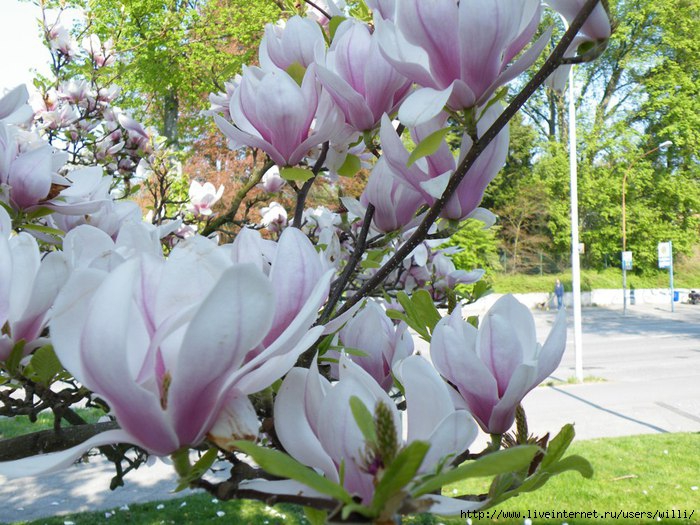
(62, 0, 280, 144)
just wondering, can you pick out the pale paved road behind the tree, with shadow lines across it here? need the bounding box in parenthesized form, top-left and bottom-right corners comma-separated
(0, 305, 700, 522)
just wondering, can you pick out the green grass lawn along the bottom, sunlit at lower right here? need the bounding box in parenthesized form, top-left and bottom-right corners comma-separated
(6, 433, 700, 525)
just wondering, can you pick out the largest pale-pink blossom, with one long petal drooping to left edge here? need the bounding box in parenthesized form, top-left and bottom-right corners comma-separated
(0, 229, 333, 476)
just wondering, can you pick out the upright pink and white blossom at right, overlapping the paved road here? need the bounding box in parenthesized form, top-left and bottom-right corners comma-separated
(430, 295, 566, 434)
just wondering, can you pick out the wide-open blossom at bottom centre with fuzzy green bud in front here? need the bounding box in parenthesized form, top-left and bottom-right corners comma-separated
(241, 355, 483, 513)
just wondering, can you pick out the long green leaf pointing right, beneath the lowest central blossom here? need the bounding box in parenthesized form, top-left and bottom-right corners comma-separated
(413, 445, 539, 497)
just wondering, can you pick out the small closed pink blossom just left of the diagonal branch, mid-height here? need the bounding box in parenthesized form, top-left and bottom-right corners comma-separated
(360, 157, 425, 232)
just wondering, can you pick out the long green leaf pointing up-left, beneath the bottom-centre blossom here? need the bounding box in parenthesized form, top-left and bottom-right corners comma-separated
(233, 441, 353, 503)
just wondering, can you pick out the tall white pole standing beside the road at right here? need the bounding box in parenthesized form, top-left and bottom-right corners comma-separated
(569, 56, 583, 383)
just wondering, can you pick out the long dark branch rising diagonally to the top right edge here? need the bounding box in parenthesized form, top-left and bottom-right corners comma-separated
(335, 0, 600, 317)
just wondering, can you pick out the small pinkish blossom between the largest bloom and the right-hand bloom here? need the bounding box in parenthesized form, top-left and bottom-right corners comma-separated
(331, 300, 413, 391)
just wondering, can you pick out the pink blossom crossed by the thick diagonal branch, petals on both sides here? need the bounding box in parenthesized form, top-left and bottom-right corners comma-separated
(380, 103, 509, 220)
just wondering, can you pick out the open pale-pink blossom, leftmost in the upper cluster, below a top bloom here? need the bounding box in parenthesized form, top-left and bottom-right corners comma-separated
(214, 64, 344, 166)
